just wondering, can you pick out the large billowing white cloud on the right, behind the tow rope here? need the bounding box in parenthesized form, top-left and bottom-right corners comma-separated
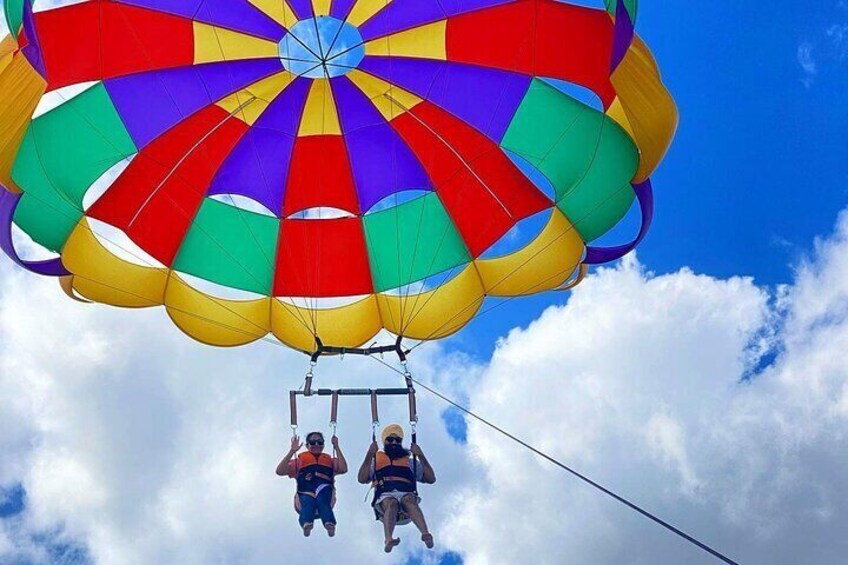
(443, 210, 848, 564)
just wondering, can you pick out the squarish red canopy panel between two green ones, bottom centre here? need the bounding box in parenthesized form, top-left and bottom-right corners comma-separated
(274, 217, 374, 297)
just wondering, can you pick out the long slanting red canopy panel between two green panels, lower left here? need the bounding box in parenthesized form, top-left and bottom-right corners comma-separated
(88, 106, 248, 266)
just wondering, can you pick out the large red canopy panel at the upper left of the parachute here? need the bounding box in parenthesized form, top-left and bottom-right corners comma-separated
(34, 1, 194, 90)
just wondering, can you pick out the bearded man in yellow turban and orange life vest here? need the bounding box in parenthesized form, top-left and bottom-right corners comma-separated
(357, 424, 436, 553)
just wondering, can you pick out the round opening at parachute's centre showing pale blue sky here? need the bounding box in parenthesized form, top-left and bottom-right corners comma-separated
(280, 16, 365, 78)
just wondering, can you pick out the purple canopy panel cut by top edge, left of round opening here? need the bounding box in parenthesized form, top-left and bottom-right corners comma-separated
(117, 0, 286, 41)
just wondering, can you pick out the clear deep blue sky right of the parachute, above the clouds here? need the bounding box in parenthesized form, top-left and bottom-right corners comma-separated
(453, 0, 848, 356)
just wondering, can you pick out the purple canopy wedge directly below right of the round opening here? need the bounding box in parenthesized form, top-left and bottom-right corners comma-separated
(332, 77, 432, 212)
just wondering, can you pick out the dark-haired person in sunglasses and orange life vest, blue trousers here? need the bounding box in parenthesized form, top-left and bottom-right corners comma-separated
(277, 432, 347, 537)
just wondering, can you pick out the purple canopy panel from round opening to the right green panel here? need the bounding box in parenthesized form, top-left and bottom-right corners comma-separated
(361, 57, 532, 143)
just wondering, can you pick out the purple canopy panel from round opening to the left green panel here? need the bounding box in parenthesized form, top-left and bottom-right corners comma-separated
(105, 59, 283, 149)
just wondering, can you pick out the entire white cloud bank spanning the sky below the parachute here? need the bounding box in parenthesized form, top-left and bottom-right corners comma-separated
(0, 208, 848, 564)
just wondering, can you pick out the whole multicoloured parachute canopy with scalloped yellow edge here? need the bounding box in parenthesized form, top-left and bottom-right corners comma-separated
(0, 0, 677, 352)
